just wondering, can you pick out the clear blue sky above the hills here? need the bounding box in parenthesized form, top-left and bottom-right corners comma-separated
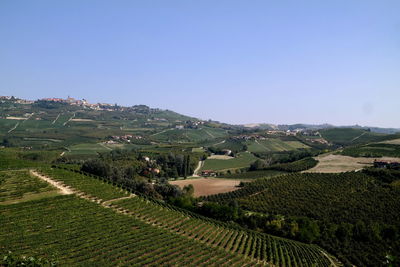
(0, 0, 400, 127)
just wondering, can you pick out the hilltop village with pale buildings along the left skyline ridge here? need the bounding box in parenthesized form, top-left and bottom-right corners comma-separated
(0, 96, 123, 110)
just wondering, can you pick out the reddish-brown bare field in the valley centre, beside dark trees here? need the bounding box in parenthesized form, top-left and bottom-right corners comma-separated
(170, 178, 240, 197)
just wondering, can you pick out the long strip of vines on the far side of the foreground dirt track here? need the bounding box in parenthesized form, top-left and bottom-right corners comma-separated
(36, 166, 340, 266)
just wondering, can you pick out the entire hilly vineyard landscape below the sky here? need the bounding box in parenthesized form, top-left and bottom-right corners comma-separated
(0, 97, 400, 266)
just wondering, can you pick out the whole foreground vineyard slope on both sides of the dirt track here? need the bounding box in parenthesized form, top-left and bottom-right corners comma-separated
(0, 164, 340, 266)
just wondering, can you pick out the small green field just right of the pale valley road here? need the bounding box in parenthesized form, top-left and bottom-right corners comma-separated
(201, 152, 257, 171)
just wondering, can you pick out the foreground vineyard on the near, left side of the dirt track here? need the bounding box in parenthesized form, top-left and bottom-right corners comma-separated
(0, 196, 255, 266)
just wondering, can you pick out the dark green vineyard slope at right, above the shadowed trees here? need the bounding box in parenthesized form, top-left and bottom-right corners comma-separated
(206, 172, 400, 223)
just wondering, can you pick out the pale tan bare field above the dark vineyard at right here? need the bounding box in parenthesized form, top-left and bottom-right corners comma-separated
(304, 154, 400, 173)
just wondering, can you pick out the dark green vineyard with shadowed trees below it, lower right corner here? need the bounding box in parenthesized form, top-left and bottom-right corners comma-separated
(203, 170, 400, 266)
